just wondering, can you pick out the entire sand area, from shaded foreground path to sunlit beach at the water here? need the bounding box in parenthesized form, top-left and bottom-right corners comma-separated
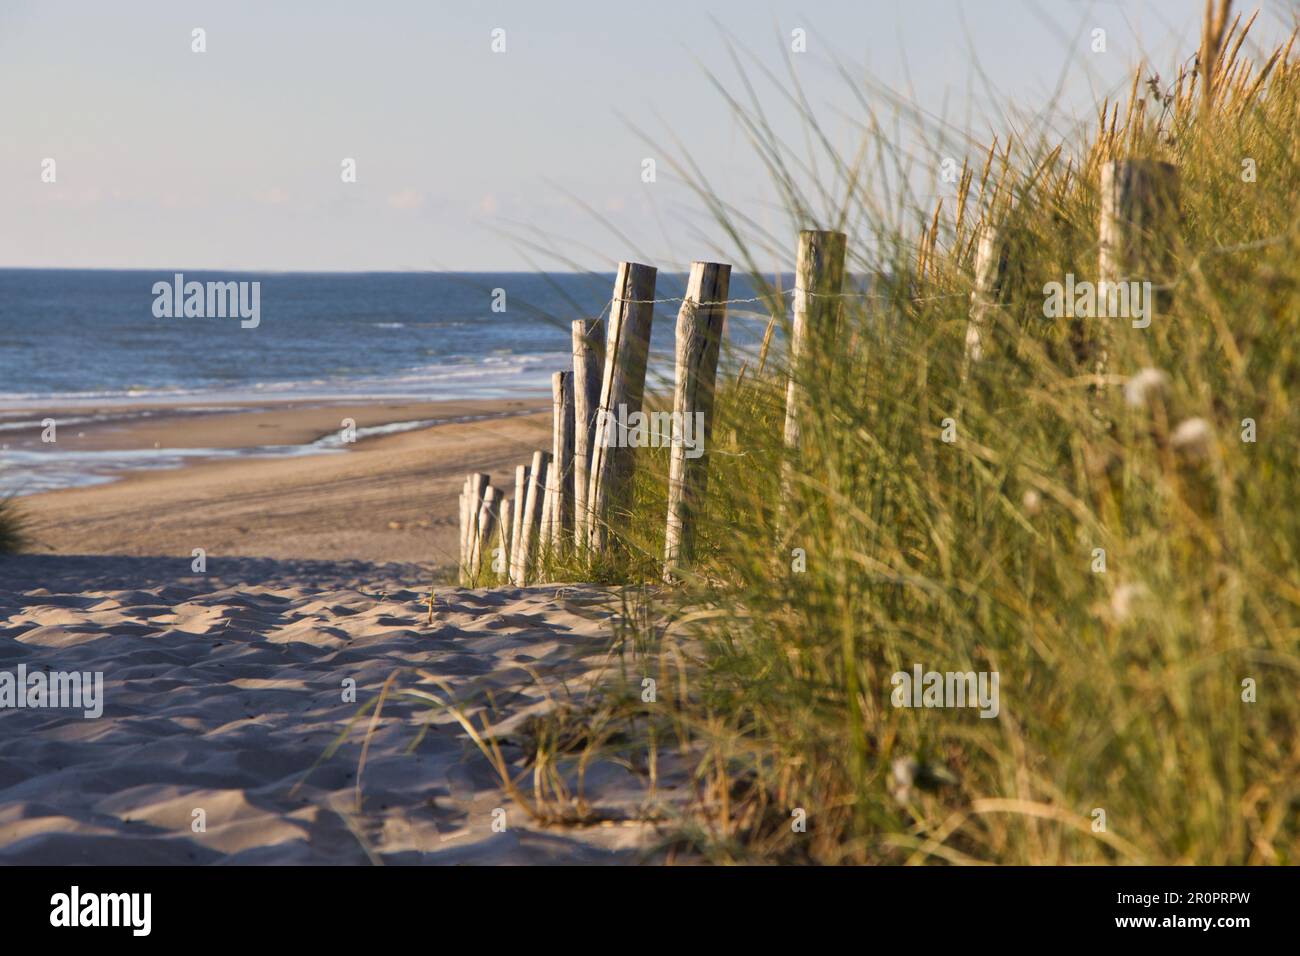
(0, 401, 671, 864)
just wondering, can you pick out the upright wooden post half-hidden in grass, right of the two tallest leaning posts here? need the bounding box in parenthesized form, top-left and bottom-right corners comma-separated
(785, 230, 848, 451)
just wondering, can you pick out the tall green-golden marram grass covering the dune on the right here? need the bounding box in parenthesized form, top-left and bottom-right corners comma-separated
(501, 14, 1300, 865)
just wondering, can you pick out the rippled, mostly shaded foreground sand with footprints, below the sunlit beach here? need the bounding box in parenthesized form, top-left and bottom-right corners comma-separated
(0, 555, 671, 864)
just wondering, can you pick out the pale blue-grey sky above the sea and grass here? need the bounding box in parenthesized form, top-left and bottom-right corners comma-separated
(0, 0, 1297, 272)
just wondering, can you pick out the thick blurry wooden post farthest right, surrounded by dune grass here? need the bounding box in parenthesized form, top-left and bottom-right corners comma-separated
(1097, 160, 1179, 384)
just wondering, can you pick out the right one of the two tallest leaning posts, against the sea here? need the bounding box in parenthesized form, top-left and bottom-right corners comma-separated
(663, 263, 731, 581)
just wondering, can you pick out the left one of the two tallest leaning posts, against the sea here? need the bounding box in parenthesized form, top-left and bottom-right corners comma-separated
(586, 263, 658, 551)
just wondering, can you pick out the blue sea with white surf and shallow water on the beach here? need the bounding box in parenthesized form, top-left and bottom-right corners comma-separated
(0, 269, 789, 494)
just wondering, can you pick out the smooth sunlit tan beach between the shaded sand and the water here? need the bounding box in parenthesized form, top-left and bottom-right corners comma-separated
(11, 399, 550, 568)
